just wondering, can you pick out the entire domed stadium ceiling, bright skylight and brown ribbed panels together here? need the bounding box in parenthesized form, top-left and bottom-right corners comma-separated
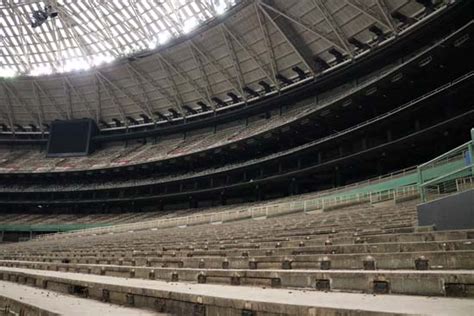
(0, 0, 436, 132)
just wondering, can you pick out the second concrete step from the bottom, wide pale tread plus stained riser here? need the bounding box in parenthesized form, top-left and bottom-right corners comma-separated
(0, 267, 474, 316)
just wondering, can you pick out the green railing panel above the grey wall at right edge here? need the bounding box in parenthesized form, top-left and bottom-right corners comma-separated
(417, 128, 474, 202)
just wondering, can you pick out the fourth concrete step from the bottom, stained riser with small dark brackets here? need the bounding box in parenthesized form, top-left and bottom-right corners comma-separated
(4, 250, 474, 270)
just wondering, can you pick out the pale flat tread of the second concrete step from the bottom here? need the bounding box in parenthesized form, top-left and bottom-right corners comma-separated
(0, 267, 474, 315)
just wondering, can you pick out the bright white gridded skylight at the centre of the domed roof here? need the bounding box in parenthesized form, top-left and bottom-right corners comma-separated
(0, 0, 239, 77)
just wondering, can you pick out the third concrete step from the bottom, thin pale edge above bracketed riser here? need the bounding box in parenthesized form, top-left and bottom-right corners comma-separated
(0, 261, 474, 297)
